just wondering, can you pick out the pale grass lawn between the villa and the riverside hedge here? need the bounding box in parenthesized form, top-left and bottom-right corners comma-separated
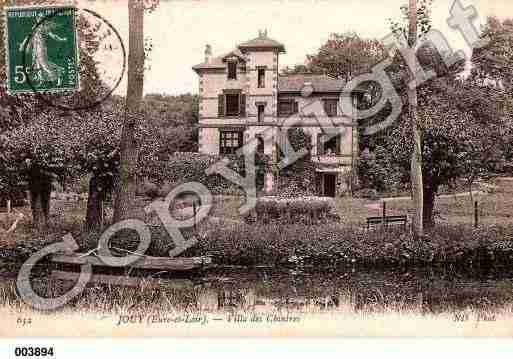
(0, 182, 513, 248)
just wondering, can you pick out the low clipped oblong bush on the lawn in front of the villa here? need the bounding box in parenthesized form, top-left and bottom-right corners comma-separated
(244, 197, 338, 224)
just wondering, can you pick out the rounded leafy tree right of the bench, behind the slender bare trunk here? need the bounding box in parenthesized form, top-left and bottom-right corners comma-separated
(387, 75, 512, 227)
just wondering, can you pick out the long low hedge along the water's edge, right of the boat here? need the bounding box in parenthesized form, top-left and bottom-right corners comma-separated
(185, 224, 513, 270)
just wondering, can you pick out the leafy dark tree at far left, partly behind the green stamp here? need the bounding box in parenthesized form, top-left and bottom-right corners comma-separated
(0, 0, 104, 228)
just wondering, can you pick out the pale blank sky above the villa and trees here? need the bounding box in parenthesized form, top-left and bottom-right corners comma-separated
(78, 0, 513, 95)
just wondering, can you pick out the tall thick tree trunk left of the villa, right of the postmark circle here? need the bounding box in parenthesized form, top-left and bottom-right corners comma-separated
(114, 0, 144, 222)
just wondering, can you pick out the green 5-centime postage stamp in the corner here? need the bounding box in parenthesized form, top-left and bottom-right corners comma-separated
(5, 6, 80, 94)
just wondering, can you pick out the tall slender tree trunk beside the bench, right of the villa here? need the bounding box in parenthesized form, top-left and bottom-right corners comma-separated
(408, 0, 424, 238)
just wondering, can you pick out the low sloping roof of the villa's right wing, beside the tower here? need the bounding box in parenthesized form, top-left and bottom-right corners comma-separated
(278, 74, 356, 92)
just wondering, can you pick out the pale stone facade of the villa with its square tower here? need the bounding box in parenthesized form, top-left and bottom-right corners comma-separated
(193, 32, 358, 196)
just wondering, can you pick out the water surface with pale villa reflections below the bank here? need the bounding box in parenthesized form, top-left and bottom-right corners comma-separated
(0, 270, 513, 313)
